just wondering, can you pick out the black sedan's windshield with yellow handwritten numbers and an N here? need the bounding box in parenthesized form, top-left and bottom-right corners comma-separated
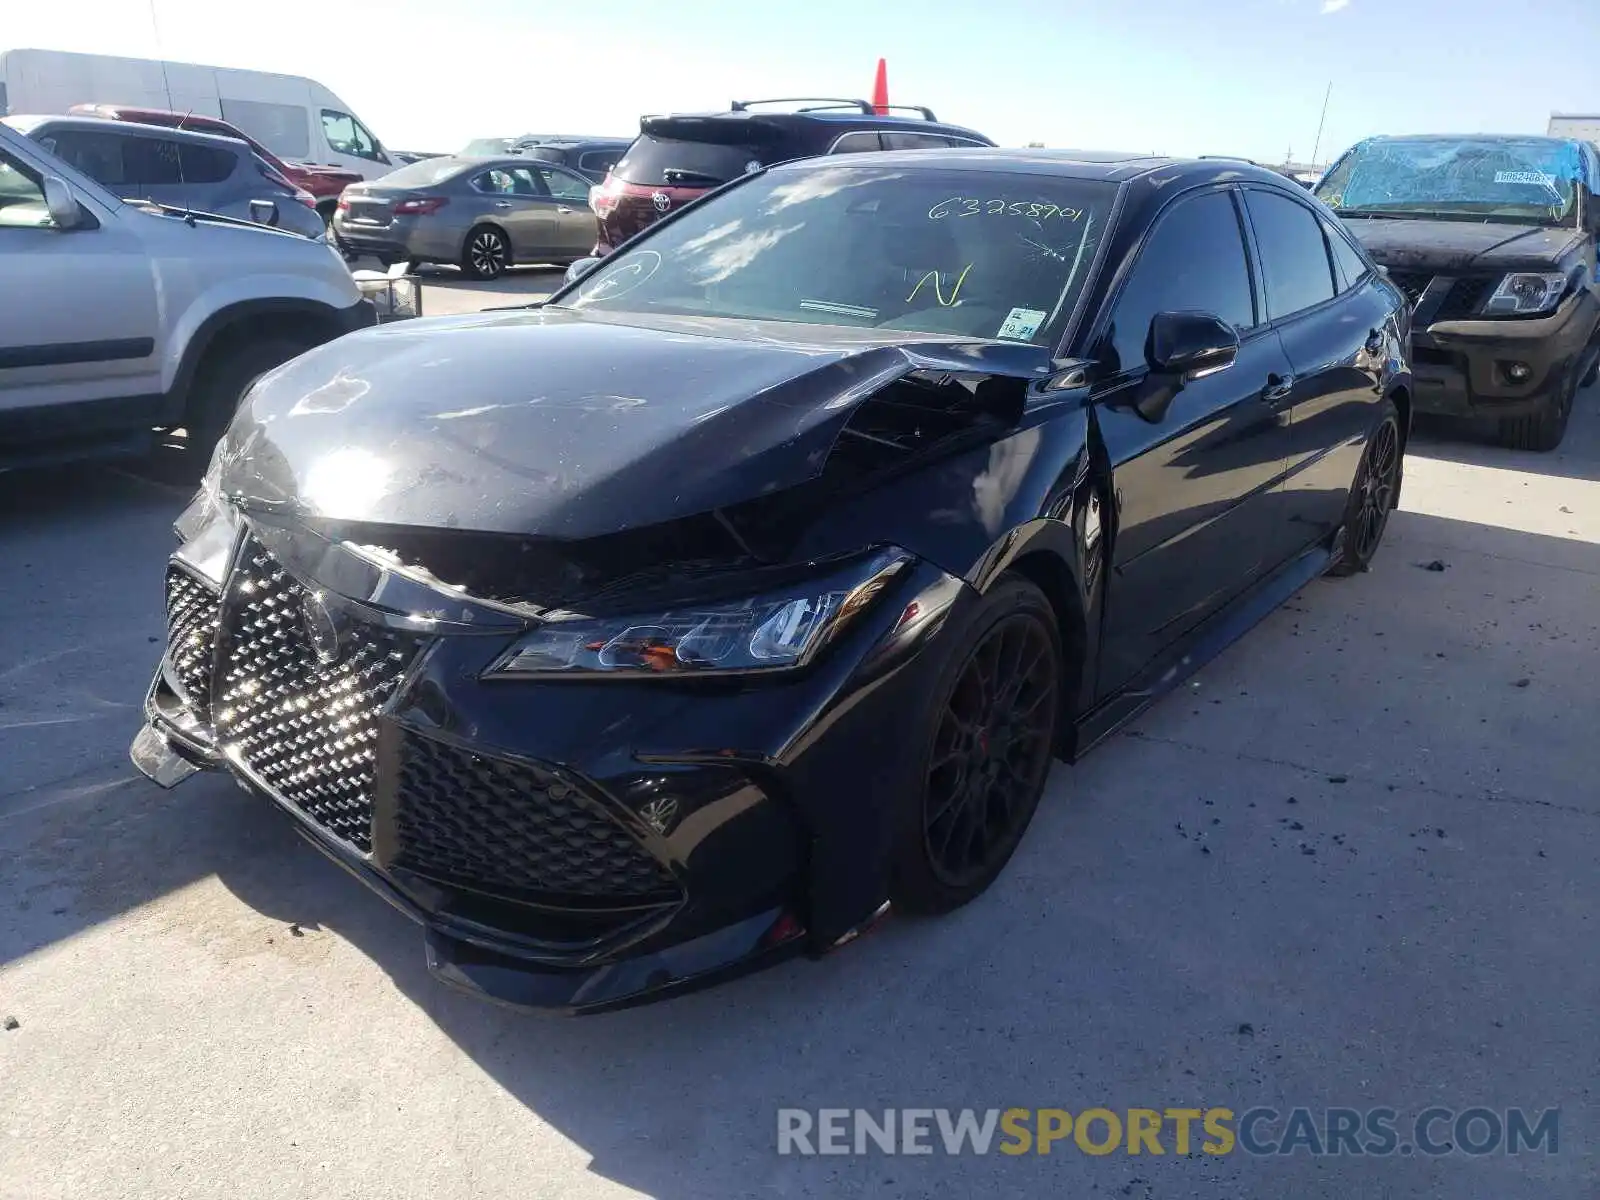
(558, 165, 1117, 344)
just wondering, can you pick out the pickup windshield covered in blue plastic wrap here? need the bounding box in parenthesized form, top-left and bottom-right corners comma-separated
(1317, 138, 1582, 226)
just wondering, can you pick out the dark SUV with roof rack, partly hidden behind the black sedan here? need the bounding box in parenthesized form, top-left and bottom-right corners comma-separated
(589, 98, 994, 254)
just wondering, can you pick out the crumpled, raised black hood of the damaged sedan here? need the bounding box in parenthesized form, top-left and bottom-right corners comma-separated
(221, 309, 1050, 539)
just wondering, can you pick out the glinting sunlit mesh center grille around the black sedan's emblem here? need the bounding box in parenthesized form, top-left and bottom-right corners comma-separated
(216, 542, 418, 854)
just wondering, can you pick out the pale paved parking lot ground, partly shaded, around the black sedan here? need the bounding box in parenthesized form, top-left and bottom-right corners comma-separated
(0, 274, 1600, 1200)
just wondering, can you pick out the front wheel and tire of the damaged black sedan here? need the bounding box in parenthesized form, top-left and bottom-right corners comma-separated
(890, 576, 1062, 914)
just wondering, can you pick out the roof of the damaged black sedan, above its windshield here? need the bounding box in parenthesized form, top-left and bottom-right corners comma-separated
(771, 146, 1290, 186)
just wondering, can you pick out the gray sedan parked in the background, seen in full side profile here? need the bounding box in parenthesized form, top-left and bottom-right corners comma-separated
(333, 155, 595, 278)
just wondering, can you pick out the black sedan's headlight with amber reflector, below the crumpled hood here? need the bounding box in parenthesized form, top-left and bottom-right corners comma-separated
(485, 549, 910, 678)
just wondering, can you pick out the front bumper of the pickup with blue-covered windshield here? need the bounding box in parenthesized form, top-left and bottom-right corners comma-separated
(1411, 290, 1600, 418)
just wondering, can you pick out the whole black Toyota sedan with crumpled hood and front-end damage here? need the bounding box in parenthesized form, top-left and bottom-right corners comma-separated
(133, 150, 1411, 1011)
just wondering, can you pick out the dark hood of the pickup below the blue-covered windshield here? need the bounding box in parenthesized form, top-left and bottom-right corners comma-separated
(1344, 218, 1582, 272)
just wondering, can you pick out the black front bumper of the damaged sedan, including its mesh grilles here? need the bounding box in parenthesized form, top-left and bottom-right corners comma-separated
(133, 531, 970, 1011)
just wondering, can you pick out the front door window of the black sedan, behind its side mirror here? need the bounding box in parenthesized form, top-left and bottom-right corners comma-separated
(1102, 192, 1256, 371)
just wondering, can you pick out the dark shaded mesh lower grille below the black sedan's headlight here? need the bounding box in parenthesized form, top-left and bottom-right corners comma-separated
(395, 733, 677, 899)
